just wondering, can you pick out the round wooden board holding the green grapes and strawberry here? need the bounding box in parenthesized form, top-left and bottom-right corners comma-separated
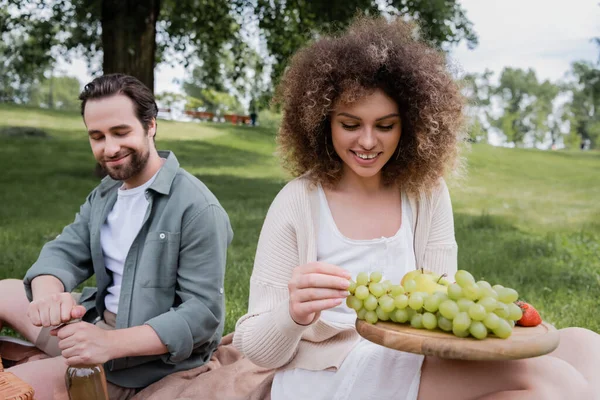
(356, 319, 560, 360)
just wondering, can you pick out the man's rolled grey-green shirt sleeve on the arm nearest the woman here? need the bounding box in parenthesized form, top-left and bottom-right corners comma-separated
(146, 205, 233, 363)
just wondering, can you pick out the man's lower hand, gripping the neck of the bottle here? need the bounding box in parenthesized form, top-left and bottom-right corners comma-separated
(50, 322, 114, 365)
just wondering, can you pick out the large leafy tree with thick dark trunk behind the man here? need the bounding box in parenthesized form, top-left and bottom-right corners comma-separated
(0, 0, 477, 94)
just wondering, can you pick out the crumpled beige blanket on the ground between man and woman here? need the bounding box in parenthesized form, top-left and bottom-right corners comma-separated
(132, 333, 275, 400)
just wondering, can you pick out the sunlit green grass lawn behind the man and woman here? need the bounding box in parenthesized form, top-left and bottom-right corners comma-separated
(0, 105, 600, 332)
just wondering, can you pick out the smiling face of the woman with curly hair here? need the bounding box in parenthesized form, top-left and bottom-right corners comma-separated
(331, 89, 402, 182)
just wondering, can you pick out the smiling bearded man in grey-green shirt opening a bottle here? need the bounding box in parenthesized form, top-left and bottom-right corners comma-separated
(0, 74, 233, 400)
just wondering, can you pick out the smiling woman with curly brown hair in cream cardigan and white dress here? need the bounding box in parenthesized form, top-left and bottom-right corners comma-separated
(234, 18, 600, 400)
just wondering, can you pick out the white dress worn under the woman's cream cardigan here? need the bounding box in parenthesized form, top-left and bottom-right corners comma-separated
(271, 186, 423, 400)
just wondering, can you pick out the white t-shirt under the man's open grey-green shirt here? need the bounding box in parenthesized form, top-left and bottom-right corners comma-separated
(100, 172, 158, 314)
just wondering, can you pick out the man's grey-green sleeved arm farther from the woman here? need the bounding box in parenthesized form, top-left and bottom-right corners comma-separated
(23, 192, 95, 301)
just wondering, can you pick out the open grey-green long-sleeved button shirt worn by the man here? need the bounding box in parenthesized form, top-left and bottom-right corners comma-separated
(24, 152, 233, 388)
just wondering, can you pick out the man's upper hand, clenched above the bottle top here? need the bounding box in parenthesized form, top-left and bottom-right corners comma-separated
(27, 292, 85, 327)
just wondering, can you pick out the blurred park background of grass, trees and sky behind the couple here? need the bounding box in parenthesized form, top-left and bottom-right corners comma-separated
(0, 0, 600, 333)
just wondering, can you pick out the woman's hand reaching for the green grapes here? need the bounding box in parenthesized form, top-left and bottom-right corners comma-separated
(288, 262, 350, 325)
